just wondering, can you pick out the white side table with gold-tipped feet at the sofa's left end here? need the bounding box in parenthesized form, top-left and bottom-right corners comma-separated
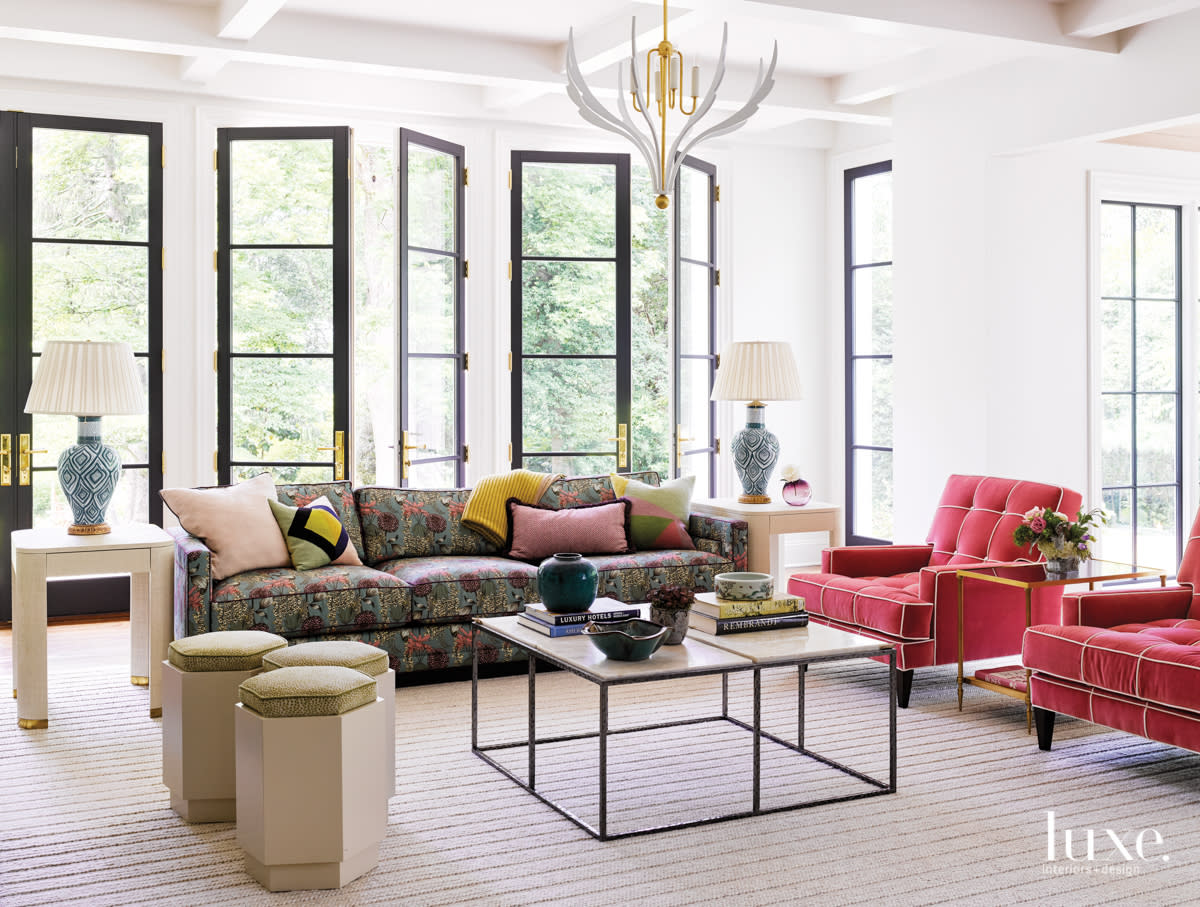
(12, 523, 175, 729)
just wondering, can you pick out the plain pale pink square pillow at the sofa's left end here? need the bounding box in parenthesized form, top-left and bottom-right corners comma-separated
(158, 473, 292, 579)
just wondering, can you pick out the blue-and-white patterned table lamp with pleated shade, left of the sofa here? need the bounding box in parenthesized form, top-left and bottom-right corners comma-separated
(25, 341, 146, 535)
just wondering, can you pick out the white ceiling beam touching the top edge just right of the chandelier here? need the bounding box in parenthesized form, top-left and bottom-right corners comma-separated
(744, 0, 1121, 54)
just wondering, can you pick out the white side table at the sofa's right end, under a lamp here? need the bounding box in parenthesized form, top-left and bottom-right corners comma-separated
(691, 498, 842, 587)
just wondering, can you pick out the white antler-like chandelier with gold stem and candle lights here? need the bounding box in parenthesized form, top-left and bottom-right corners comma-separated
(566, 0, 779, 208)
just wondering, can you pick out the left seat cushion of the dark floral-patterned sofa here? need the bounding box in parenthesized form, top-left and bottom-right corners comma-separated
(202, 565, 412, 637)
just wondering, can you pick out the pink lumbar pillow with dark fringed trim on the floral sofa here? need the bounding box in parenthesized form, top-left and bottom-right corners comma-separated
(505, 498, 634, 560)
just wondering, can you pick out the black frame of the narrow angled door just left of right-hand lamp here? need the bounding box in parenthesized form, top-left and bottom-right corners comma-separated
(671, 156, 718, 498)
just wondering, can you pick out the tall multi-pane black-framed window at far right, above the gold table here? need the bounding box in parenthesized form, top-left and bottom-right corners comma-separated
(1099, 202, 1183, 566)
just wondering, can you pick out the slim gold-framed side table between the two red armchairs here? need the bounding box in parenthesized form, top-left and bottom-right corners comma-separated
(955, 559, 1166, 733)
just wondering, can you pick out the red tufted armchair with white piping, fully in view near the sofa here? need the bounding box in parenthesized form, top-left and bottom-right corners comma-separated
(787, 475, 1082, 708)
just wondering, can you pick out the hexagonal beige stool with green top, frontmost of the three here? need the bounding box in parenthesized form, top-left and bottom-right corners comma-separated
(234, 666, 388, 891)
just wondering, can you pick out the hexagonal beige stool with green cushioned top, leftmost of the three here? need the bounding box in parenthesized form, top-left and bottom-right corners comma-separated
(162, 630, 288, 822)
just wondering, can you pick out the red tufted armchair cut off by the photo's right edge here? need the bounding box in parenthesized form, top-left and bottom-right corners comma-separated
(1021, 506, 1200, 752)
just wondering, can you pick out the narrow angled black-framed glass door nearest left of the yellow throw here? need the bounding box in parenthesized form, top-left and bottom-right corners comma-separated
(396, 128, 468, 488)
